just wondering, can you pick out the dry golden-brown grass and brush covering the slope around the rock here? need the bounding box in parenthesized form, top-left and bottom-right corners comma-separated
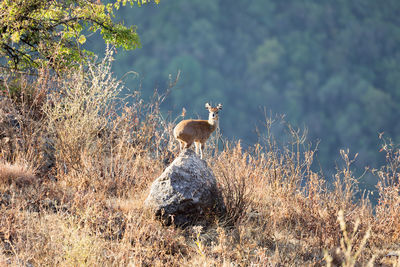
(0, 49, 400, 266)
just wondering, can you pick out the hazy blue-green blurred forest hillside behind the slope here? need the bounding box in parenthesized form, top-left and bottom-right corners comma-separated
(87, 0, 400, 180)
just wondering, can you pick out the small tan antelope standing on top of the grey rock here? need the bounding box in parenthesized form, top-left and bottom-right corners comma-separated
(174, 103, 222, 159)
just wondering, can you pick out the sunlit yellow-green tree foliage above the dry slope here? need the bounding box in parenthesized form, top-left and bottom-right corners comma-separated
(0, 0, 158, 70)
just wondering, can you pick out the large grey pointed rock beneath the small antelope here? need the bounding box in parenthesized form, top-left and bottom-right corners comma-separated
(145, 149, 223, 226)
